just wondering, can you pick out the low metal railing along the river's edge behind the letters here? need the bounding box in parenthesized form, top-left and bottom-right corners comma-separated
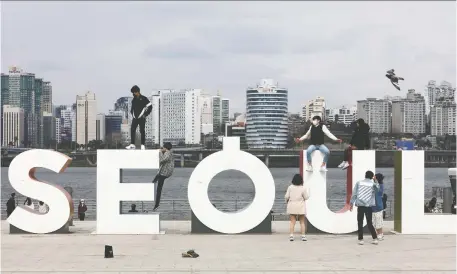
(1, 197, 394, 221)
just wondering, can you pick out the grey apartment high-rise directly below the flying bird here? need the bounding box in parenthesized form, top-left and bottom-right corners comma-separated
(392, 89, 426, 135)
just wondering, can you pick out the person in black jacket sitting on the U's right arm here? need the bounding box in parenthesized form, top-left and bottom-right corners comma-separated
(338, 118, 370, 170)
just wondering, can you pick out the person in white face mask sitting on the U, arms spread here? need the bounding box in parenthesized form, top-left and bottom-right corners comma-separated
(295, 116, 341, 172)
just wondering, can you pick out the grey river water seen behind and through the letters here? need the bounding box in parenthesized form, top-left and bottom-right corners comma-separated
(1, 167, 450, 219)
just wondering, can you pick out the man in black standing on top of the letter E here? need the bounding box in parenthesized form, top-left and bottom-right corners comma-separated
(126, 85, 152, 150)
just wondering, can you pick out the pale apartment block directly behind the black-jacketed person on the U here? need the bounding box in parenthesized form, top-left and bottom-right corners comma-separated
(357, 98, 392, 133)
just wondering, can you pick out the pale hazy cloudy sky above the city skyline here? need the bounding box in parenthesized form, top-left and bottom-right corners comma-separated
(1, 1, 456, 112)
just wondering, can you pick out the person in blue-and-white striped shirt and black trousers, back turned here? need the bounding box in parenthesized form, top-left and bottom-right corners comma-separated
(350, 170, 379, 245)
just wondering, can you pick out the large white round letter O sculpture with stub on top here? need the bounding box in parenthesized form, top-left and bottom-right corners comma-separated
(188, 137, 275, 234)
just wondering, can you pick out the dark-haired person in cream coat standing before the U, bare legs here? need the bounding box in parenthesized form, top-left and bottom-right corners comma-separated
(285, 174, 309, 241)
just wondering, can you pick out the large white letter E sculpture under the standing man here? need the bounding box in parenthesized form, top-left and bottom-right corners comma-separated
(97, 149, 160, 234)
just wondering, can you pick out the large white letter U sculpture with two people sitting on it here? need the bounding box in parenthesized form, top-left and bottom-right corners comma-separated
(302, 150, 376, 234)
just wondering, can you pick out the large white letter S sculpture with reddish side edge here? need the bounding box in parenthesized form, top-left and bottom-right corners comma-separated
(7, 149, 73, 233)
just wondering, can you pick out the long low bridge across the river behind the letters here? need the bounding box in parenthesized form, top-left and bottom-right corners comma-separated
(2, 148, 456, 168)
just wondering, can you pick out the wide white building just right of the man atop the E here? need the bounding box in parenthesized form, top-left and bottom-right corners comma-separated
(160, 89, 201, 145)
